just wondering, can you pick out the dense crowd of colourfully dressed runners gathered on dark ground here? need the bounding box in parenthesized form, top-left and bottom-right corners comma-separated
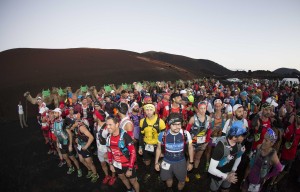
(25, 80, 300, 192)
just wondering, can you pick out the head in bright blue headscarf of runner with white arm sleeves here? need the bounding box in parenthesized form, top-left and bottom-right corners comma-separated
(228, 121, 247, 143)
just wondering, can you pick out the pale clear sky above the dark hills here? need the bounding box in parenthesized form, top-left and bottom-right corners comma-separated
(0, 0, 300, 71)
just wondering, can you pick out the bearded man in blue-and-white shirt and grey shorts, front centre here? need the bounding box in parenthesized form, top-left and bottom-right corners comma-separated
(155, 113, 194, 192)
